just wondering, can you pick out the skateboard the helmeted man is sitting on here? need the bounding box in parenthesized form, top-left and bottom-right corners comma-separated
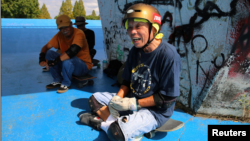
(144, 118, 184, 139)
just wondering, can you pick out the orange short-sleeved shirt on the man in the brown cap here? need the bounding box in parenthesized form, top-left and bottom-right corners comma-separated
(49, 28, 93, 70)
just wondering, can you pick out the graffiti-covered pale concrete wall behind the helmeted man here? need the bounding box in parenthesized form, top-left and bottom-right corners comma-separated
(98, 0, 250, 116)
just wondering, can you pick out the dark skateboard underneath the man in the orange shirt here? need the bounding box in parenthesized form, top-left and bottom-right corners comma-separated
(72, 74, 96, 88)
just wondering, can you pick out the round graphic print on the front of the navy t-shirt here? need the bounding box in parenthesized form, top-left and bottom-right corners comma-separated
(130, 63, 152, 96)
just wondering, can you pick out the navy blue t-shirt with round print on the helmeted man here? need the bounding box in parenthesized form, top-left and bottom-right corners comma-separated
(122, 41, 181, 127)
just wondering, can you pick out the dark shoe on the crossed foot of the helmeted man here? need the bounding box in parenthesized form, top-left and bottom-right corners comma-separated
(79, 113, 103, 131)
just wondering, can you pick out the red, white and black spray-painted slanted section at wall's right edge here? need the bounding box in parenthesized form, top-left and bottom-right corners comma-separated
(202, 12, 250, 116)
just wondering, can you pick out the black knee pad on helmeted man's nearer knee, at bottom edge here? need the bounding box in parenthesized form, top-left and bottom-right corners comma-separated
(107, 120, 125, 141)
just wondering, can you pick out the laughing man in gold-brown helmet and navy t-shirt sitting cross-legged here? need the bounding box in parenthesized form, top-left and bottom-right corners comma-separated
(79, 3, 181, 141)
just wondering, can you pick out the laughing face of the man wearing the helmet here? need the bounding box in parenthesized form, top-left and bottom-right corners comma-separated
(128, 20, 149, 48)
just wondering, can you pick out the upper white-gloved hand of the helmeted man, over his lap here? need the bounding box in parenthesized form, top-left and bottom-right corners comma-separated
(109, 97, 137, 111)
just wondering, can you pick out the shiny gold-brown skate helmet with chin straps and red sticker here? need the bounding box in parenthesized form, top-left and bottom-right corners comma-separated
(123, 3, 163, 50)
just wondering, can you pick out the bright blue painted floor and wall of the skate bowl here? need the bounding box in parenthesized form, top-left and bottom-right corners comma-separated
(1, 19, 249, 141)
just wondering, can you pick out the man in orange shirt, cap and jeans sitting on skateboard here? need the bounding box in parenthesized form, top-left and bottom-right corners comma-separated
(39, 15, 93, 93)
